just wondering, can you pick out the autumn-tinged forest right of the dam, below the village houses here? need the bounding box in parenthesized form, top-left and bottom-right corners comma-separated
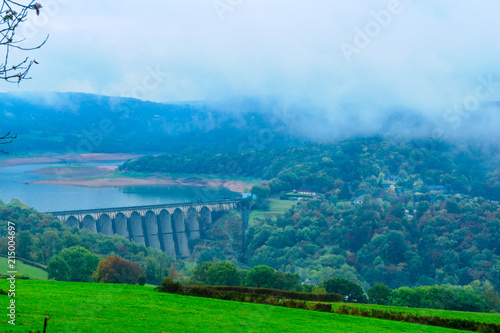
(246, 195, 500, 290)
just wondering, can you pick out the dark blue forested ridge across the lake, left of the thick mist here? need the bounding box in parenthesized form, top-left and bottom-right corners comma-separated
(0, 93, 300, 154)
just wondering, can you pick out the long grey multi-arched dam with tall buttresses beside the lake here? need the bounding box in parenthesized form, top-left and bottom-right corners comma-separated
(51, 200, 242, 258)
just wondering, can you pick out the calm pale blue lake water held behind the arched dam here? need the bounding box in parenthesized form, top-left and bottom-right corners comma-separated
(0, 162, 241, 212)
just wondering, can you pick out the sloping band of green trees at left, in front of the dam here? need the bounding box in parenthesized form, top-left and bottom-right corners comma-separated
(0, 200, 173, 283)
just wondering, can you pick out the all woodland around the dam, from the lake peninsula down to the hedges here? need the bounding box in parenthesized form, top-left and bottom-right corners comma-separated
(0, 137, 500, 304)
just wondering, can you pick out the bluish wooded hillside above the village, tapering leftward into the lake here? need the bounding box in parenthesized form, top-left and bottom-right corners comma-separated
(121, 137, 500, 200)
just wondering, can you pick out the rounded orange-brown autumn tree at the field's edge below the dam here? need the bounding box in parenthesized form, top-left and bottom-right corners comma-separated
(94, 256, 144, 284)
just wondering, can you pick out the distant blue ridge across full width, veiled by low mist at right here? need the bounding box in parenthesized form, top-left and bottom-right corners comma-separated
(0, 93, 500, 153)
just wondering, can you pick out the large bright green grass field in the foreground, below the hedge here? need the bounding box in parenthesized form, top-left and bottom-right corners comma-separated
(0, 280, 461, 333)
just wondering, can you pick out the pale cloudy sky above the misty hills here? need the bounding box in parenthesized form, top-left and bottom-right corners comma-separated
(0, 0, 500, 118)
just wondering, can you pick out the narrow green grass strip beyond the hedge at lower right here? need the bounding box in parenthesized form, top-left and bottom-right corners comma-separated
(333, 304, 500, 324)
